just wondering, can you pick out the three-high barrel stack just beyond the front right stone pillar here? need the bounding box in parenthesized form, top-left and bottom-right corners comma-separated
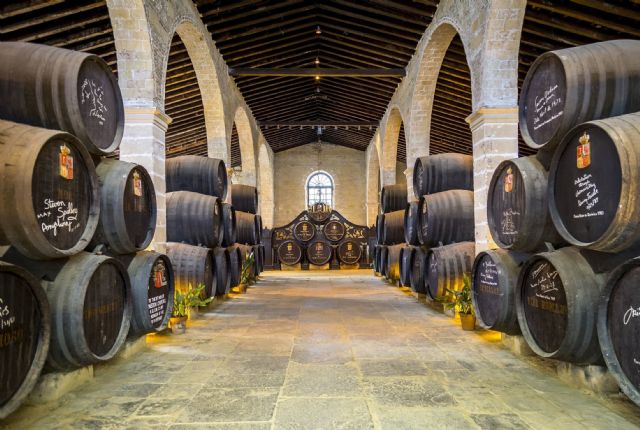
(401, 153, 475, 300)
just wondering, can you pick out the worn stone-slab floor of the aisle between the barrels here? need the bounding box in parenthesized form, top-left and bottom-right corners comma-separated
(0, 271, 640, 430)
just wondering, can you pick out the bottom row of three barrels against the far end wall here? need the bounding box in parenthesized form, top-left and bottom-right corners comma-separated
(277, 239, 363, 266)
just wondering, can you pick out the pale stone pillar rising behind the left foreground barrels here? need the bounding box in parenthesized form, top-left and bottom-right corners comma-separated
(120, 106, 171, 252)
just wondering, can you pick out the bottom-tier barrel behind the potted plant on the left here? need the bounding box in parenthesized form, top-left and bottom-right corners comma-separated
(167, 242, 217, 298)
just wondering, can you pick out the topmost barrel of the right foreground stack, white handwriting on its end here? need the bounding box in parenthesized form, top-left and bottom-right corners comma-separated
(519, 40, 640, 153)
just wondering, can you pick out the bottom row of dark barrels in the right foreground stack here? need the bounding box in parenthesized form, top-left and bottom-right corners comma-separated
(472, 247, 640, 404)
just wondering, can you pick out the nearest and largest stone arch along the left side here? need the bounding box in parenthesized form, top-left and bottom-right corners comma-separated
(160, 19, 229, 163)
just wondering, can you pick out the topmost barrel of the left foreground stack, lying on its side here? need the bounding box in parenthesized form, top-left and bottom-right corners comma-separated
(0, 42, 124, 155)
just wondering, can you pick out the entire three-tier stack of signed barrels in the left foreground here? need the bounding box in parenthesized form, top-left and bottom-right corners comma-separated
(0, 43, 173, 418)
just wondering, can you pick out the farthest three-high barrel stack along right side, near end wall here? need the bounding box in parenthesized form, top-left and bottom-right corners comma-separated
(373, 184, 407, 283)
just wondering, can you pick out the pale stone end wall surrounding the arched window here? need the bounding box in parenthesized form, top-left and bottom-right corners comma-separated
(274, 144, 367, 227)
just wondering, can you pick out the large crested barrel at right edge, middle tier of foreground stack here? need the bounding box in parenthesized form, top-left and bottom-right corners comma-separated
(549, 114, 640, 252)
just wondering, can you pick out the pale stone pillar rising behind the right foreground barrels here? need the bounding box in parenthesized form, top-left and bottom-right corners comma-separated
(467, 107, 518, 254)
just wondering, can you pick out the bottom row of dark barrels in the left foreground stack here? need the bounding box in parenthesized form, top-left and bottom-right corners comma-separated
(0, 247, 174, 418)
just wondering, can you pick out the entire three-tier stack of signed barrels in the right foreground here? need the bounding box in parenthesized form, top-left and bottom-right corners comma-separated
(473, 40, 640, 404)
